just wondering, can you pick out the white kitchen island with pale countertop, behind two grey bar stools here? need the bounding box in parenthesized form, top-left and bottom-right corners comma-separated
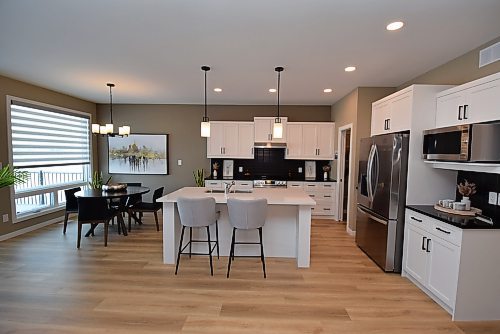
(158, 187, 316, 268)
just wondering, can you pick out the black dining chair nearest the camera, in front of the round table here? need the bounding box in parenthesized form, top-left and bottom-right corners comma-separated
(76, 197, 120, 248)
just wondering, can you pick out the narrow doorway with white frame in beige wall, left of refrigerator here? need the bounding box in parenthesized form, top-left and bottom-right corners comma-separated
(337, 124, 353, 228)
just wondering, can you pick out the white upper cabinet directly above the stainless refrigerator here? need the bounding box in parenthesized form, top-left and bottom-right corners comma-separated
(371, 89, 413, 136)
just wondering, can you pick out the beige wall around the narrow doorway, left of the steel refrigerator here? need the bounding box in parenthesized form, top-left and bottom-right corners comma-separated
(331, 87, 395, 230)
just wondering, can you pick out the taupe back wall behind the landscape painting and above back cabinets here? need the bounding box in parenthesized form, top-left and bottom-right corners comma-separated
(97, 105, 330, 199)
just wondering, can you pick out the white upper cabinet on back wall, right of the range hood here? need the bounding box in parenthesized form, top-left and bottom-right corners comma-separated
(285, 122, 335, 160)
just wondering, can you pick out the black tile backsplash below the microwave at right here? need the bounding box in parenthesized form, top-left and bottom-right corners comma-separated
(456, 171, 500, 221)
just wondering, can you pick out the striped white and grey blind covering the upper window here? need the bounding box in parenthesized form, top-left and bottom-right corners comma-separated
(10, 101, 90, 168)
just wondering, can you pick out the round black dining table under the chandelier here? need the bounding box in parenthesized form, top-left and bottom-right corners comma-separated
(75, 186, 150, 237)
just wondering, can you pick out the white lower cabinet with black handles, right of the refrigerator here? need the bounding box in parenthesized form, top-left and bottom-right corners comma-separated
(402, 209, 500, 321)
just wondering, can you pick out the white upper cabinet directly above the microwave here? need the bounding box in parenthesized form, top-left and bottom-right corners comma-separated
(436, 72, 500, 128)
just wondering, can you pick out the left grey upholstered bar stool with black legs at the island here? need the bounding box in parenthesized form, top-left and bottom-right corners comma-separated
(175, 197, 219, 276)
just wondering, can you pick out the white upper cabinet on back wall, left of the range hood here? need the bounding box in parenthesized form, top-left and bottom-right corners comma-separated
(207, 121, 254, 159)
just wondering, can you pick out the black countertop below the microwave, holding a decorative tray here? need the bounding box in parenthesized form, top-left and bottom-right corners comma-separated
(406, 205, 500, 229)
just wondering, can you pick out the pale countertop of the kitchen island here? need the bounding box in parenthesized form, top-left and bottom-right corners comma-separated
(158, 187, 316, 206)
